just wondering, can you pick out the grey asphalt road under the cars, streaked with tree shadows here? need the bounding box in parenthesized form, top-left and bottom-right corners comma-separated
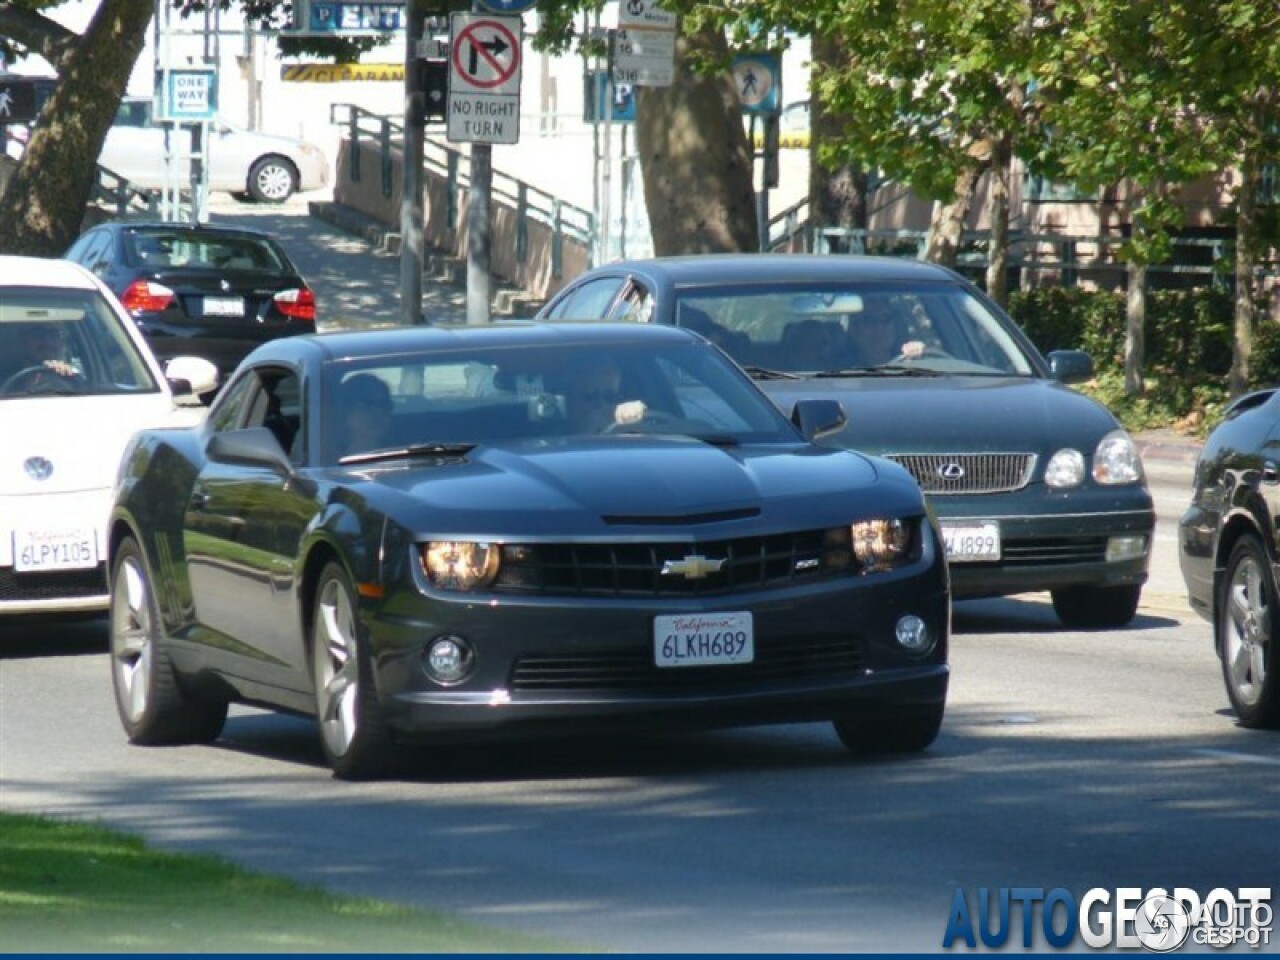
(0, 465, 1280, 952)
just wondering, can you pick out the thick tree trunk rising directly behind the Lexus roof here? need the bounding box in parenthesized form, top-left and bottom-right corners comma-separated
(635, 31, 760, 256)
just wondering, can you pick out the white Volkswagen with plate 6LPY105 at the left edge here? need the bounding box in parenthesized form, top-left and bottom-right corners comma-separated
(0, 256, 218, 616)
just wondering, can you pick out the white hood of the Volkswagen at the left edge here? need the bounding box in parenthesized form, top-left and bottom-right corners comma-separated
(0, 393, 189, 497)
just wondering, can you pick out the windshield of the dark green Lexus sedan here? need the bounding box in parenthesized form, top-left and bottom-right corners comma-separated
(676, 284, 1034, 376)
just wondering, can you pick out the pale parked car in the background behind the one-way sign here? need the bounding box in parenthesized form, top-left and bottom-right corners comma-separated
(97, 97, 329, 204)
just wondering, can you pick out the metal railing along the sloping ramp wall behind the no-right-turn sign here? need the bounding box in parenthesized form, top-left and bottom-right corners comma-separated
(329, 104, 596, 276)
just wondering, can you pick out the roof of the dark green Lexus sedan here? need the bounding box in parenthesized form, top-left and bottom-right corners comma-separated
(608, 253, 956, 285)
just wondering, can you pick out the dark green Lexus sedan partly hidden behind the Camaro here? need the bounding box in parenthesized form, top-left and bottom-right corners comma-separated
(539, 255, 1155, 628)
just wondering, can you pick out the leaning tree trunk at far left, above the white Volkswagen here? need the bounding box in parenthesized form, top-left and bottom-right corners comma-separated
(0, 0, 155, 256)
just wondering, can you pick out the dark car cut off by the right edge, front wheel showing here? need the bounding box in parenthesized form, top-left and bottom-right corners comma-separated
(1178, 389, 1280, 728)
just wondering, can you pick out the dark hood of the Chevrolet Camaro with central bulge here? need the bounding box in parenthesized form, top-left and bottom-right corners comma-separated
(340, 436, 922, 535)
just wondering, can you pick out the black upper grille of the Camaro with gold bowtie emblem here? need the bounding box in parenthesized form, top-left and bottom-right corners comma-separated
(493, 529, 854, 596)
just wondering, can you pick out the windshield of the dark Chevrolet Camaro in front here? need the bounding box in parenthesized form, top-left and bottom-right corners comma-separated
(324, 343, 797, 463)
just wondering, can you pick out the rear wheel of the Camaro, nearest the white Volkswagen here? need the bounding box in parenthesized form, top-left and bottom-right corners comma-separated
(110, 538, 227, 746)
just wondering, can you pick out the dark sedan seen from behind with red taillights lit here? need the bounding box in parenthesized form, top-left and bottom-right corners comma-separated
(63, 220, 316, 381)
